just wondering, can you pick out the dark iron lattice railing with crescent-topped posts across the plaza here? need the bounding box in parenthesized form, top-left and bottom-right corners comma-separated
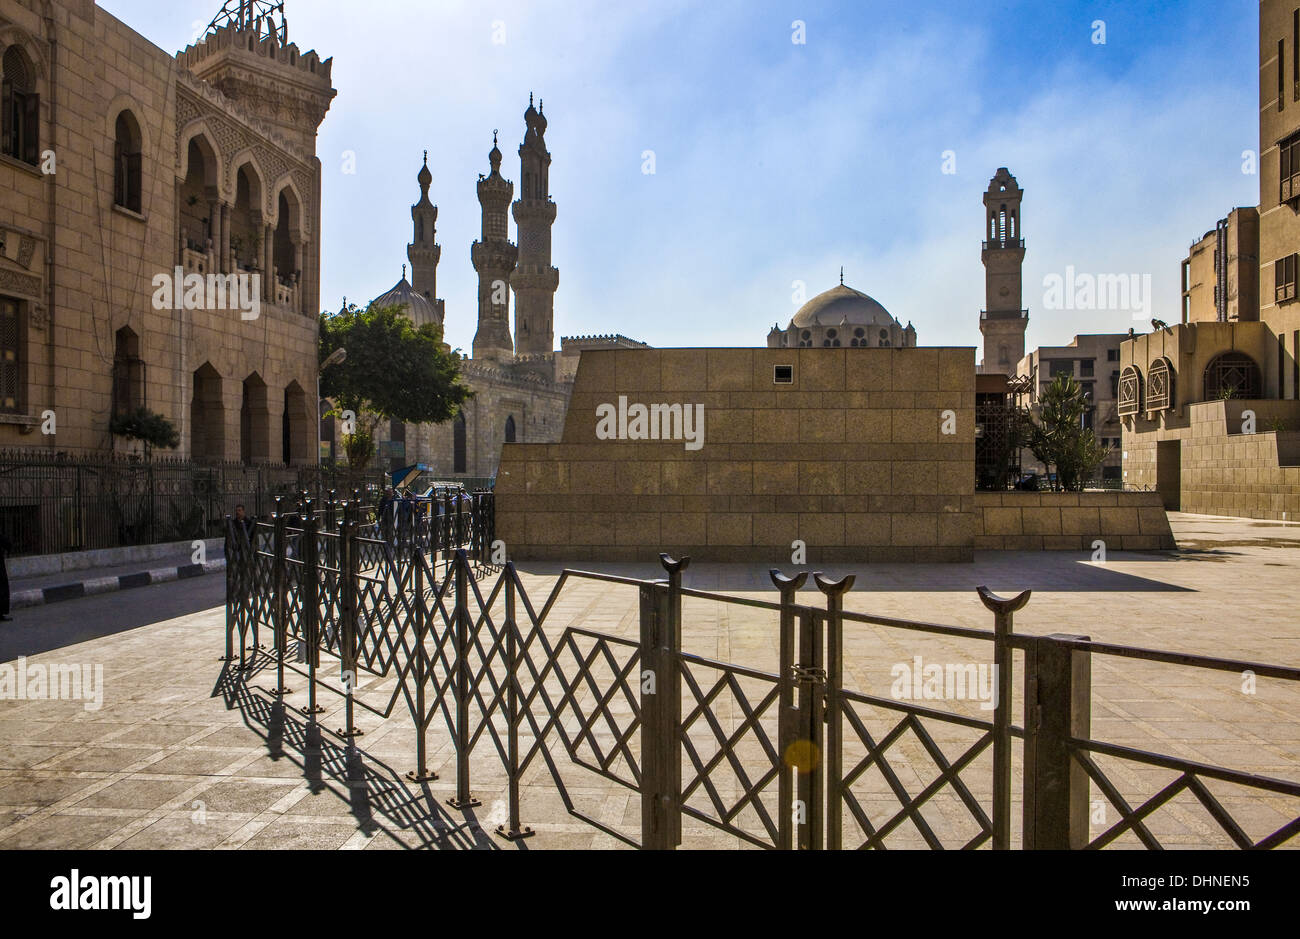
(226, 497, 1300, 849)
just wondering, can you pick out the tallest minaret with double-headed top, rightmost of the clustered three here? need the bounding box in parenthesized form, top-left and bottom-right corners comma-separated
(510, 95, 560, 355)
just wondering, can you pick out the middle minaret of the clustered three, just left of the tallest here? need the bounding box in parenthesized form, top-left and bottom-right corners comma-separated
(469, 130, 519, 363)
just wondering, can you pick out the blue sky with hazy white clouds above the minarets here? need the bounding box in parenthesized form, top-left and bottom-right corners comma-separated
(100, 0, 1258, 350)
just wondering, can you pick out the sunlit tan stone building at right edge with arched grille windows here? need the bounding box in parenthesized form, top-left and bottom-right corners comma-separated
(1119, 0, 1300, 520)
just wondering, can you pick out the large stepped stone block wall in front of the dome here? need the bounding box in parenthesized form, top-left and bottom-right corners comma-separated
(497, 349, 975, 564)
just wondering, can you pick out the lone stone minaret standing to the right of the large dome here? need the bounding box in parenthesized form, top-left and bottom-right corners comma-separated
(979, 166, 1030, 375)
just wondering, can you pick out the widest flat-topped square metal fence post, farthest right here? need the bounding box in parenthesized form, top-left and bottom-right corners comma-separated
(1023, 635, 1092, 851)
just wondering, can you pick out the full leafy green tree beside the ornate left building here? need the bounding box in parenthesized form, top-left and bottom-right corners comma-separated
(319, 304, 473, 470)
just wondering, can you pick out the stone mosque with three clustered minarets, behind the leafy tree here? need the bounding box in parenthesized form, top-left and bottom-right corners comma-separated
(361, 100, 644, 477)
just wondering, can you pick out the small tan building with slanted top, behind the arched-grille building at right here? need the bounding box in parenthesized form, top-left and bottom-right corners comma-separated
(1179, 205, 1260, 323)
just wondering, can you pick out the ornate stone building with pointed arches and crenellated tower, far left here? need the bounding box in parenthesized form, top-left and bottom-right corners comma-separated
(0, 0, 335, 463)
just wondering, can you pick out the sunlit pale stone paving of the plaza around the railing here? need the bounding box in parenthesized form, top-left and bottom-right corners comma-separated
(0, 514, 1300, 851)
